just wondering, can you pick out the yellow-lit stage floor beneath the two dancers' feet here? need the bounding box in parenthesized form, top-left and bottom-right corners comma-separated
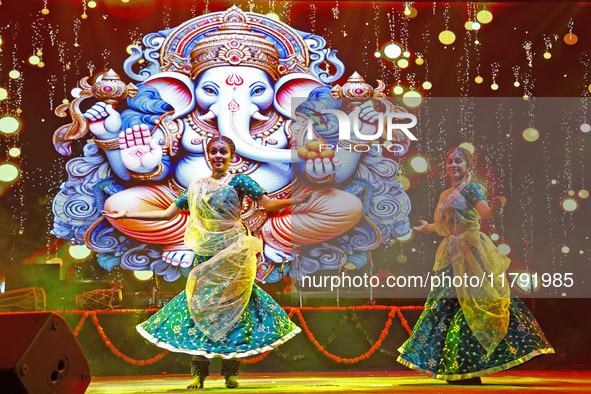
(86, 371, 591, 394)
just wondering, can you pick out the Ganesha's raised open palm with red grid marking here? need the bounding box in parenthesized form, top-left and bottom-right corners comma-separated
(119, 124, 162, 173)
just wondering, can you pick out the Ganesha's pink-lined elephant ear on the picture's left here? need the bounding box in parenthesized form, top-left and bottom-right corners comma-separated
(143, 72, 195, 119)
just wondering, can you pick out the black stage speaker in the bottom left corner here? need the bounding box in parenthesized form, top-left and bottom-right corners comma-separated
(0, 312, 90, 394)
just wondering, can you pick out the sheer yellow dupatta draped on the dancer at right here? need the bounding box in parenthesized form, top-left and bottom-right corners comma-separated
(433, 183, 510, 355)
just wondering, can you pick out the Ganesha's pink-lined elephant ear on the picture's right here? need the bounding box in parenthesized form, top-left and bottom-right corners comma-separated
(274, 73, 325, 118)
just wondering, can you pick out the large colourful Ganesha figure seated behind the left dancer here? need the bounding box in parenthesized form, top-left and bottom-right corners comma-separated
(53, 6, 410, 282)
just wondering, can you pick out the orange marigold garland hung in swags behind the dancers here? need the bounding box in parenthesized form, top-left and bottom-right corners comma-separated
(60, 305, 423, 366)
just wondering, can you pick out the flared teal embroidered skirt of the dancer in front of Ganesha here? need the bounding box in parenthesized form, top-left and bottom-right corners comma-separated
(136, 284, 301, 358)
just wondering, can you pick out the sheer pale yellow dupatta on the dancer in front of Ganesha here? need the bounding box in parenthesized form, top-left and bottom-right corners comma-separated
(185, 175, 262, 341)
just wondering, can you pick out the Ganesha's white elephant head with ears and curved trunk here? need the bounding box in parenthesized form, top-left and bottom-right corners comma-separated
(144, 65, 324, 163)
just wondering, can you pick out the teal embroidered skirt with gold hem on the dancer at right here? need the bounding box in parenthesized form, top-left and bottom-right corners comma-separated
(398, 272, 554, 380)
